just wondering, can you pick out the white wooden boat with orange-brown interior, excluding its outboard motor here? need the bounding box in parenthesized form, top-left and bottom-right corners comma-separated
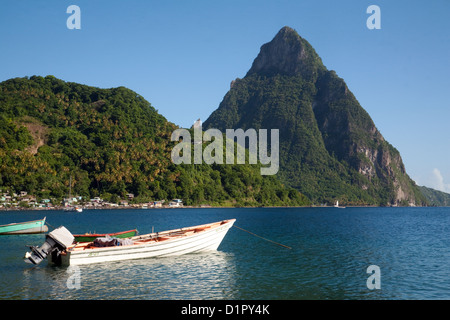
(45, 219, 236, 265)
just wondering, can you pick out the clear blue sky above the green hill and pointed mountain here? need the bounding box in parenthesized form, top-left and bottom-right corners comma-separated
(0, 0, 450, 192)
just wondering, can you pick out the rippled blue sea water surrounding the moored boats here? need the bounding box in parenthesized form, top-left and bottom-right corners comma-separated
(0, 208, 450, 300)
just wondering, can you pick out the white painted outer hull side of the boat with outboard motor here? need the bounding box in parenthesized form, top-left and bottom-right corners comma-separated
(50, 219, 235, 266)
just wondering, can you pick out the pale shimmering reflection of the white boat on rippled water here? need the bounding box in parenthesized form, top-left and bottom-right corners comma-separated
(62, 252, 239, 300)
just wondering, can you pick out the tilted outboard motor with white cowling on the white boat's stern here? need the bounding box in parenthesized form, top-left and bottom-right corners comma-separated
(25, 227, 75, 264)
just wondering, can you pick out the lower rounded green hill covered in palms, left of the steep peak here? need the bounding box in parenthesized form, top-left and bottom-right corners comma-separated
(0, 76, 308, 206)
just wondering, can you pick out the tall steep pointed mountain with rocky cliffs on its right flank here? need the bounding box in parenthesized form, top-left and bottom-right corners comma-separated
(204, 27, 427, 205)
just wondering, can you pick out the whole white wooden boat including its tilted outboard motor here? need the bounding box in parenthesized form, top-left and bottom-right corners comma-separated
(25, 219, 236, 266)
